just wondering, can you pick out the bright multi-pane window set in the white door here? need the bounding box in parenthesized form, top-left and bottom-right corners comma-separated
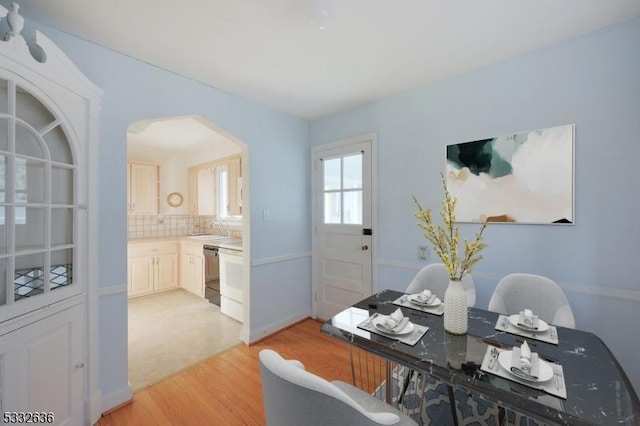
(322, 153, 363, 225)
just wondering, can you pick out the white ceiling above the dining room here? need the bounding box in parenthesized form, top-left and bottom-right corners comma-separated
(16, 0, 640, 119)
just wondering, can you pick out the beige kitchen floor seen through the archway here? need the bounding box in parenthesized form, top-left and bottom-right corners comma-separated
(129, 290, 242, 392)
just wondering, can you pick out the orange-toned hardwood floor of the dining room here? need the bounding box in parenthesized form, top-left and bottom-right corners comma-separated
(98, 319, 351, 426)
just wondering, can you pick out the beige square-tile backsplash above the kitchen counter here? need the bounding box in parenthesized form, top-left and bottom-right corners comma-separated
(127, 215, 242, 240)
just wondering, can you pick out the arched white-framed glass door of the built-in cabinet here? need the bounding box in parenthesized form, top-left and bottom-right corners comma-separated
(0, 79, 77, 312)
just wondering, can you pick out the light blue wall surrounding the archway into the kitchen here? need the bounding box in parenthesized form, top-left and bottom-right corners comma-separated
(31, 23, 311, 408)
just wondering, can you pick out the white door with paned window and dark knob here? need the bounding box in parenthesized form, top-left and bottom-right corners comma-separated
(312, 135, 375, 319)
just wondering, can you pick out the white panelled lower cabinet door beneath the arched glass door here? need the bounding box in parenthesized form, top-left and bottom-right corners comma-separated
(0, 304, 86, 426)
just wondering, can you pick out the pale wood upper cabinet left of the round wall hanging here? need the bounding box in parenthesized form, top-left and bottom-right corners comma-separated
(127, 161, 160, 215)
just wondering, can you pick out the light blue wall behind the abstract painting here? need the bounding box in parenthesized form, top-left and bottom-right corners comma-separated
(311, 20, 640, 390)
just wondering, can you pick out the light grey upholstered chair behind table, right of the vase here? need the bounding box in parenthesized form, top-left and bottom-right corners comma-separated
(489, 273, 576, 328)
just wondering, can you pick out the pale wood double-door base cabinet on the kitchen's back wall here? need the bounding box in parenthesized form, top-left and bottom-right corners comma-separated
(127, 242, 179, 297)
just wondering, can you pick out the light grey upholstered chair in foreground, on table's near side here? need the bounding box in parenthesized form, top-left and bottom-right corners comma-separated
(259, 349, 417, 426)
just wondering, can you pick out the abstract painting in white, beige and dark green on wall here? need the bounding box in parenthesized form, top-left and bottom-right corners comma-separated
(446, 124, 575, 224)
